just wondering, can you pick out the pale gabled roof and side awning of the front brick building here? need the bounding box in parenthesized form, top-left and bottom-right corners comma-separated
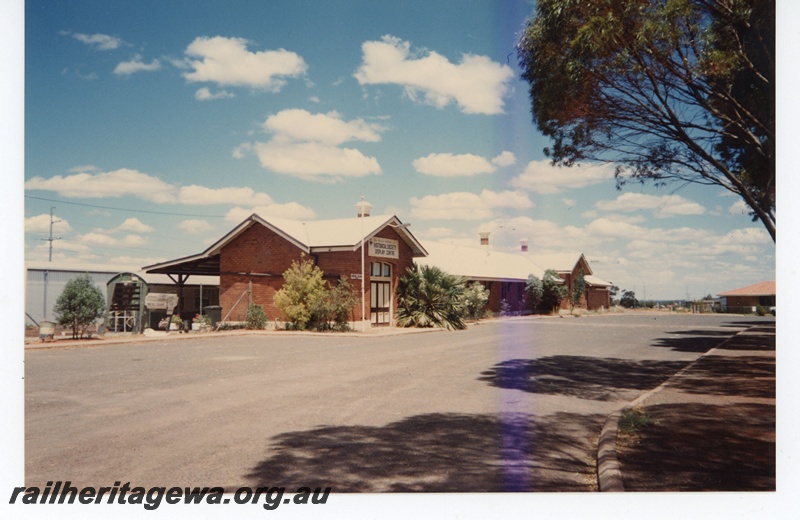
(142, 213, 427, 274)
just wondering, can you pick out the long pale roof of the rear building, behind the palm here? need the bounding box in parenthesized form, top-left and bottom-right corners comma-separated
(417, 241, 544, 281)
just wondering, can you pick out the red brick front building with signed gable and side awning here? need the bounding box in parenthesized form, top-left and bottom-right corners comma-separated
(143, 203, 426, 325)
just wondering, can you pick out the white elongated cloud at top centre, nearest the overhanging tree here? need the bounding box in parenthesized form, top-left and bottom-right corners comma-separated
(354, 35, 514, 114)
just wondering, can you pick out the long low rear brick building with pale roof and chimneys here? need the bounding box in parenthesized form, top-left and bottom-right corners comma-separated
(417, 233, 612, 313)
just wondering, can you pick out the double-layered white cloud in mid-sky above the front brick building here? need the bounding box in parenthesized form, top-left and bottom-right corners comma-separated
(241, 109, 385, 182)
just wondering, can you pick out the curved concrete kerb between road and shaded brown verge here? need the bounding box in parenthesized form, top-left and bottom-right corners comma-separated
(597, 329, 749, 492)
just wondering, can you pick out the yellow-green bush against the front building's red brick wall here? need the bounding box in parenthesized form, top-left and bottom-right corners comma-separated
(275, 255, 325, 330)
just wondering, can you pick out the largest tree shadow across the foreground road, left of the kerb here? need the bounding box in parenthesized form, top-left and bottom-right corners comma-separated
(245, 413, 604, 493)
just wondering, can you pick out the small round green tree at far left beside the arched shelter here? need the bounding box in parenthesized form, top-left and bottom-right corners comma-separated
(54, 274, 106, 339)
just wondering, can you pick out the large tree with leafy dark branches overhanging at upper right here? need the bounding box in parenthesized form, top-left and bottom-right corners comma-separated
(517, 0, 775, 240)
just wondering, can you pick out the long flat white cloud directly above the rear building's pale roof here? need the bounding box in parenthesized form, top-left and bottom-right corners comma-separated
(411, 190, 533, 220)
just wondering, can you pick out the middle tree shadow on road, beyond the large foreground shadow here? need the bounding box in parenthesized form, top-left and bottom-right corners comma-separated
(478, 356, 687, 401)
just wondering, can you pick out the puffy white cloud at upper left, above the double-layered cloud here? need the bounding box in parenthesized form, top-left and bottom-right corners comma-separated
(183, 36, 308, 92)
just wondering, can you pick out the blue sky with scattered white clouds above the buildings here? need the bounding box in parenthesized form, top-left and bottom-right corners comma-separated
(24, 0, 775, 299)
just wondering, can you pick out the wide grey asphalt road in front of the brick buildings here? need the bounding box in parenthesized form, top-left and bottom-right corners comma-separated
(25, 314, 768, 492)
